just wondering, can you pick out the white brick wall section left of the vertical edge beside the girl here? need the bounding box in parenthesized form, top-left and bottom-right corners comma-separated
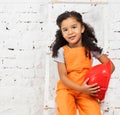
(0, 0, 48, 115)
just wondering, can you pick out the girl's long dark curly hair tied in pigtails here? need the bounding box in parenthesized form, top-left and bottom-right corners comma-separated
(51, 11, 102, 58)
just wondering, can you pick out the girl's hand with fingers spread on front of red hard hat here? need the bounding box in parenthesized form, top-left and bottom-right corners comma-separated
(81, 78, 100, 96)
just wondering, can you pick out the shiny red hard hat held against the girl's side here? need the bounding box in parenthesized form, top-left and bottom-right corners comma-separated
(86, 60, 111, 100)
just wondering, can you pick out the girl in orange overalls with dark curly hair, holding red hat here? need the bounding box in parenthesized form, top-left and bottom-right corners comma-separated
(52, 11, 115, 115)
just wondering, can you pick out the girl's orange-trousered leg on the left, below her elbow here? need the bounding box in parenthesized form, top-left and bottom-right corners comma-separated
(56, 89, 76, 115)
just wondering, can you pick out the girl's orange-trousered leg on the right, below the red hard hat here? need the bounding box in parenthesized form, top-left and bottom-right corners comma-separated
(76, 94, 102, 115)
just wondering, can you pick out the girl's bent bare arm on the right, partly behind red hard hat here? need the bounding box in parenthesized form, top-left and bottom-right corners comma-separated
(98, 54, 115, 73)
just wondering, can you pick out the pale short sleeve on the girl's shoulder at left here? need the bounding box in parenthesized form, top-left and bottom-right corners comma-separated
(54, 47, 65, 63)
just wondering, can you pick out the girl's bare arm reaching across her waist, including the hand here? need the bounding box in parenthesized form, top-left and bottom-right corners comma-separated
(57, 62, 100, 96)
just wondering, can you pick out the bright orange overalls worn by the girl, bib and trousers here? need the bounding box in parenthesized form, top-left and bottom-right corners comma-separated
(56, 46, 101, 115)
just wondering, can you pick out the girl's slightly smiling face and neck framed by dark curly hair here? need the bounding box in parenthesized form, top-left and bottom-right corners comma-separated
(61, 17, 84, 47)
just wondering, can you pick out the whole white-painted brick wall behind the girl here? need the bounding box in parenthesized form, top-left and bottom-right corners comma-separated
(0, 0, 120, 115)
